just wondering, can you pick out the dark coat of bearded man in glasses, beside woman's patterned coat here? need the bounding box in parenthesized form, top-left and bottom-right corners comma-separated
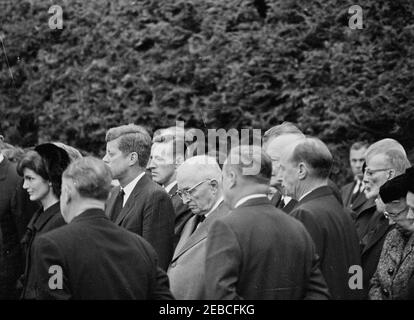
(360, 211, 394, 297)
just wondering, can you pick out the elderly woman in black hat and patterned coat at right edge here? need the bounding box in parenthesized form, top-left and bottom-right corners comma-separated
(369, 168, 414, 300)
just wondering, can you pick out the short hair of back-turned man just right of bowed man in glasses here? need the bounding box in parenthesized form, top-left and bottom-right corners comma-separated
(224, 145, 272, 185)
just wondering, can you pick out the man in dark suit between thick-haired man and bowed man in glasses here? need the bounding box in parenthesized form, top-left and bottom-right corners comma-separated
(147, 134, 193, 248)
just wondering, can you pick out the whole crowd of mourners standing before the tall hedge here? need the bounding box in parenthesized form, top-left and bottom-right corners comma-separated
(0, 122, 414, 300)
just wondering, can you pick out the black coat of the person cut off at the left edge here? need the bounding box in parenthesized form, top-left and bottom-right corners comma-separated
(0, 158, 38, 300)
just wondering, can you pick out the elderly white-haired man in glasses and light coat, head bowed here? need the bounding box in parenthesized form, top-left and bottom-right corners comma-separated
(168, 155, 229, 300)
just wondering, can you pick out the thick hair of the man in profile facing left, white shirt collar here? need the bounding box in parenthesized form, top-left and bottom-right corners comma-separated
(105, 124, 151, 168)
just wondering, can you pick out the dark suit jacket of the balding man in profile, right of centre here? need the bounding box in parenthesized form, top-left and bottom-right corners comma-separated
(291, 186, 361, 300)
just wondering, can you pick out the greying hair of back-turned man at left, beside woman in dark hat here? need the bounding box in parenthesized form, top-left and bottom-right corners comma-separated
(63, 157, 112, 201)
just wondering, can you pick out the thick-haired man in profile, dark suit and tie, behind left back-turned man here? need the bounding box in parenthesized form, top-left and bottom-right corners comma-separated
(103, 124, 175, 270)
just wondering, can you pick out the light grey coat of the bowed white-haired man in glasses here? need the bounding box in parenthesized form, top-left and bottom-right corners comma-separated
(168, 202, 230, 300)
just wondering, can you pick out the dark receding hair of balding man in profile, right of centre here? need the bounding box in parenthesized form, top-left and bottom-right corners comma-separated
(291, 137, 333, 180)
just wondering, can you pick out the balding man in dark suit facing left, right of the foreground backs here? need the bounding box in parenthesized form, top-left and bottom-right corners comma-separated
(281, 138, 361, 300)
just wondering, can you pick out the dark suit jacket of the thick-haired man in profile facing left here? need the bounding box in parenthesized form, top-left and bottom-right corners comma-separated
(105, 174, 175, 270)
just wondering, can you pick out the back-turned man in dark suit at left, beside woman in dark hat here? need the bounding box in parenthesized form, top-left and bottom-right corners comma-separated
(29, 157, 172, 300)
